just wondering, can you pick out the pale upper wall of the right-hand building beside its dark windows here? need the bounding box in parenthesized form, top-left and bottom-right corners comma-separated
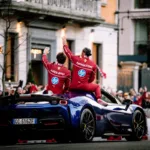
(119, 0, 150, 55)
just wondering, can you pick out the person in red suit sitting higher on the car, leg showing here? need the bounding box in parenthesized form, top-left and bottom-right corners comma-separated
(63, 37, 107, 106)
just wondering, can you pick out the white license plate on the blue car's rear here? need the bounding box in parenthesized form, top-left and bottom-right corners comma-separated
(13, 118, 37, 125)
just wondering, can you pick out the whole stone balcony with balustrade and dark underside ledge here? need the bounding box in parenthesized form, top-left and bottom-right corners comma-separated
(0, 0, 104, 26)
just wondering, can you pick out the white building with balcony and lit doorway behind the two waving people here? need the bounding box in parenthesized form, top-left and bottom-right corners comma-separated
(0, 0, 117, 88)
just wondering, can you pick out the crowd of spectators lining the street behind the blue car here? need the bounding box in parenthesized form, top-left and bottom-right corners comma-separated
(0, 82, 150, 108)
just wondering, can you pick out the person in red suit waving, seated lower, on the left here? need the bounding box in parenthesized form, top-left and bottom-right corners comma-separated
(42, 47, 71, 94)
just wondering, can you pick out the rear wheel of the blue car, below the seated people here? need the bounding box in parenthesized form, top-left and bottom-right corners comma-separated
(76, 108, 95, 142)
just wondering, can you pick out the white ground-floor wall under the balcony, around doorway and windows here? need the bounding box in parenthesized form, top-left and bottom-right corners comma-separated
(0, 22, 117, 89)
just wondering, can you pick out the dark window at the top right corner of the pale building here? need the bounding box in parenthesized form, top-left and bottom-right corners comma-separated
(135, 0, 150, 8)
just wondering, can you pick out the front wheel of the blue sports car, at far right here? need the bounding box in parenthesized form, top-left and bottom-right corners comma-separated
(125, 110, 146, 141)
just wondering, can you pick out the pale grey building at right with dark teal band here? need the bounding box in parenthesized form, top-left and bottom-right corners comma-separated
(116, 0, 150, 91)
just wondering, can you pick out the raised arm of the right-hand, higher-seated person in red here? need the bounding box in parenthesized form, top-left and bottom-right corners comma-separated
(62, 37, 73, 60)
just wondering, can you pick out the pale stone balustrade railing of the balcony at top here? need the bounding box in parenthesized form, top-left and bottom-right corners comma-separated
(12, 0, 100, 18)
